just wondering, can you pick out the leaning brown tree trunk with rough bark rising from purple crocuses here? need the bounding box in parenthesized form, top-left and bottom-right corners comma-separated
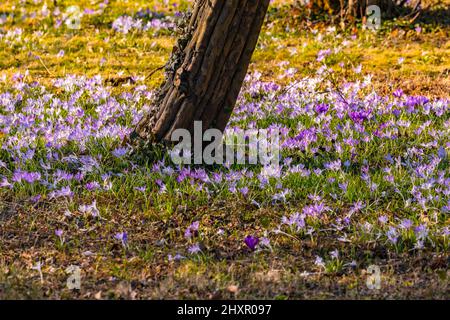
(130, 0, 270, 142)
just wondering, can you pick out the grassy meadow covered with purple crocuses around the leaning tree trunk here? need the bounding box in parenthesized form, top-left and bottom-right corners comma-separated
(0, 0, 450, 299)
